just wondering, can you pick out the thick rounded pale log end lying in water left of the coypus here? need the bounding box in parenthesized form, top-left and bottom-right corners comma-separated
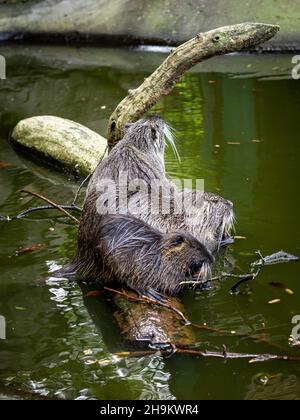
(11, 115, 107, 176)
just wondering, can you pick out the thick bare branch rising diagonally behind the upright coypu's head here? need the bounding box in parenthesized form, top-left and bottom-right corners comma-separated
(108, 23, 280, 149)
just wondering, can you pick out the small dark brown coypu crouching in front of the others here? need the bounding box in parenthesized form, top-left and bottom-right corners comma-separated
(62, 215, 213, 300)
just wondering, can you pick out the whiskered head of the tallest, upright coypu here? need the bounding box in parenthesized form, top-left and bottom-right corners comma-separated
(122, 115, 179, 160)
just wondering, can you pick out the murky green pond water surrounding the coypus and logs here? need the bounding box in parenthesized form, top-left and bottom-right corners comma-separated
(0, 46, 300, 400)
